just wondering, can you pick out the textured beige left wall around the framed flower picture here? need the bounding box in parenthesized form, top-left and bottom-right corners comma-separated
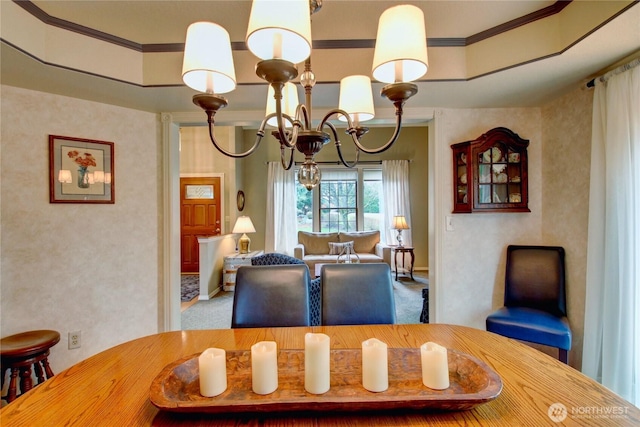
(0, 86, 162, 372)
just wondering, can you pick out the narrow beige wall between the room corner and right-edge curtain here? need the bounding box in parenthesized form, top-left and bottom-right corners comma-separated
(542, 89, 593, 369)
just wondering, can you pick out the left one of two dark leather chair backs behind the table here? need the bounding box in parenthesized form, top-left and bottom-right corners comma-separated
(231, 264, 311, 328)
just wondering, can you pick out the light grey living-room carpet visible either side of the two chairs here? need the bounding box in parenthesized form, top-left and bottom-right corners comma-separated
(181, 273, 429, 330)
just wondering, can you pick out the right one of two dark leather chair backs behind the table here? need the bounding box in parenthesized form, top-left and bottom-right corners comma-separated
(320, 263, 396, 325)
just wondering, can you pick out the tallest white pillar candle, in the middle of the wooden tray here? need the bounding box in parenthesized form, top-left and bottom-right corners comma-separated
(304, 333, 331, 394)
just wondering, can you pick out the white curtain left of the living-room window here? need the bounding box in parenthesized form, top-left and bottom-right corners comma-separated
(265, 162, 298, 256)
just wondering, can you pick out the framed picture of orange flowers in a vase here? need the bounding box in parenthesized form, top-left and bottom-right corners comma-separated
(49, 135, 115, 203)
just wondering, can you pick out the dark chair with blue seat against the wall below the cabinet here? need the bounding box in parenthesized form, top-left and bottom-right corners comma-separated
(486, 245, 571, 363)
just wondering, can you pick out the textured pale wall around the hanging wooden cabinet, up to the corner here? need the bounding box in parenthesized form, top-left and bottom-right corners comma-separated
(432, 108, 542, 329)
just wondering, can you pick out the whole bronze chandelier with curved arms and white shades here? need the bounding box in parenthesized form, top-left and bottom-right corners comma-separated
(182, 0, 428, 190)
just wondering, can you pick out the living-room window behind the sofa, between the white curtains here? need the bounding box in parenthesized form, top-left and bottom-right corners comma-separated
(296, 167, 382, 233)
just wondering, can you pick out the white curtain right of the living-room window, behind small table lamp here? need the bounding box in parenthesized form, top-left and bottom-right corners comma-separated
(380, 160, 412, 251)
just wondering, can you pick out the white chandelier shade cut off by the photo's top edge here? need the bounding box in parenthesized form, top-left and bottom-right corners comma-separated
(246, 0, 311, 64)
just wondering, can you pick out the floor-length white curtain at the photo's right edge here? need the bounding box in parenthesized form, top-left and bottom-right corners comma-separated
(582, 60, 640, 406)
